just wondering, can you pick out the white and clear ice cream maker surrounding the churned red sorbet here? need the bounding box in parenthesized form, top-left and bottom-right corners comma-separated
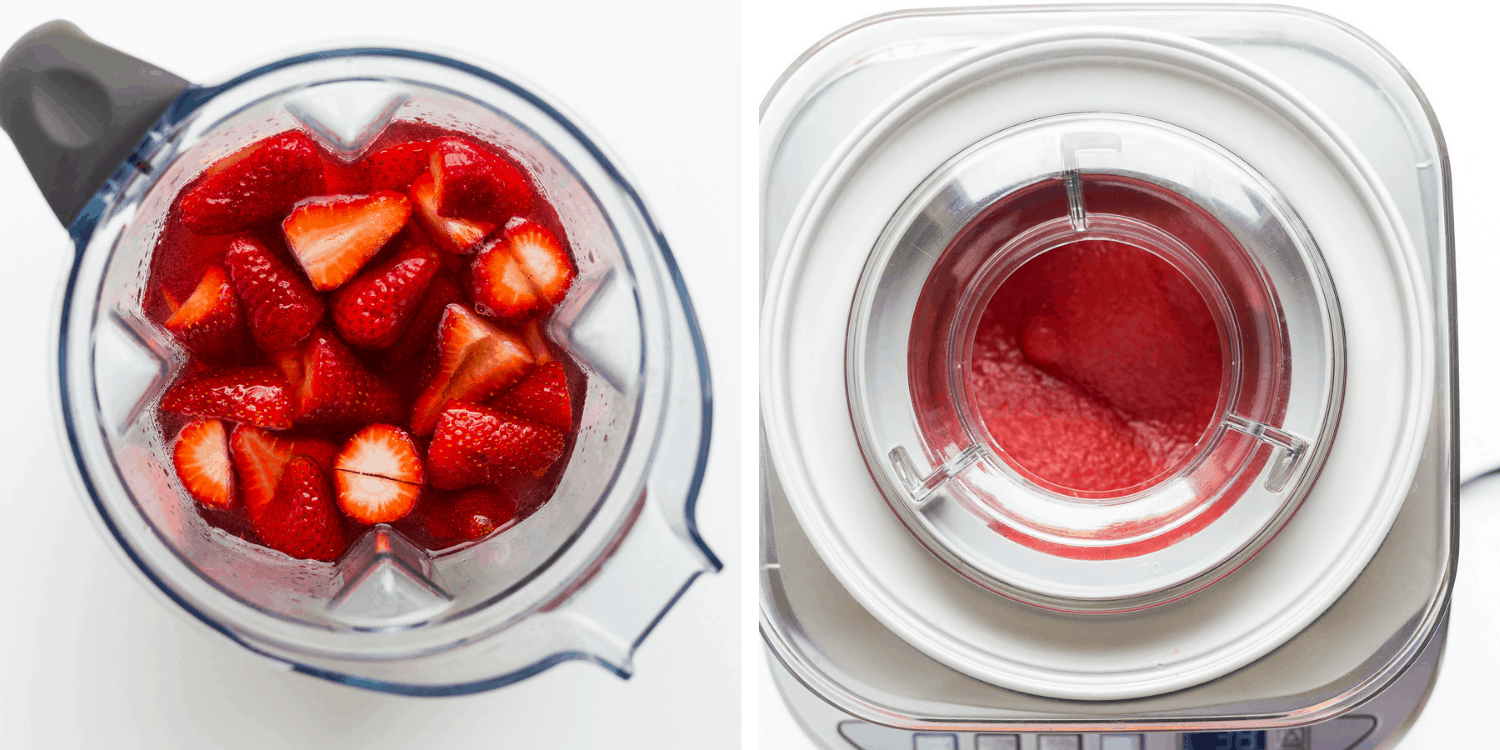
(759, 6, 1457, 750)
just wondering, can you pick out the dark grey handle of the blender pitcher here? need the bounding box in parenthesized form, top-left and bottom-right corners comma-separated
(0, 21, 188, 227)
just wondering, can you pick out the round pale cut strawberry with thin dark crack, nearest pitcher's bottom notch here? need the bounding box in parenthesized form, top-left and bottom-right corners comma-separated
(333, 425, 423, 524)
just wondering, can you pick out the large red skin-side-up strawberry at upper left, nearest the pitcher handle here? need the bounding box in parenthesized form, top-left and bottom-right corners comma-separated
(177, 131, 324, 234)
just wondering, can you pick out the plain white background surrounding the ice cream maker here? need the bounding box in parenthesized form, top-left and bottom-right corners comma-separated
(744, 0, 1500, 750)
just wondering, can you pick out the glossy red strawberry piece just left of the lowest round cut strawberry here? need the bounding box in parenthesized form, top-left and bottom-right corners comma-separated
(252, 455, 350, 563)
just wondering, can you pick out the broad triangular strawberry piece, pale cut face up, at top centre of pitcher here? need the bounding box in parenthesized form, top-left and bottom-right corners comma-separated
(282, 191, 411, 291)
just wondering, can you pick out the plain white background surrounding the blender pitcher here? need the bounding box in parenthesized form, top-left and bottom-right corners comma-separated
(0, 0, 743, 750)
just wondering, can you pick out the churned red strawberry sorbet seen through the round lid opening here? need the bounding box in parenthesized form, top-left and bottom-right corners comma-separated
(966, 240, 1224, 494)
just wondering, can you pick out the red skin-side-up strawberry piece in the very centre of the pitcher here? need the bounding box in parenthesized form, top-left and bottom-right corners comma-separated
(296, 330, 405, 426)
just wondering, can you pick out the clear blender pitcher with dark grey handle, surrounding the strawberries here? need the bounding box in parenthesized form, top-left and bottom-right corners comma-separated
(0, 23, 720, 695)
